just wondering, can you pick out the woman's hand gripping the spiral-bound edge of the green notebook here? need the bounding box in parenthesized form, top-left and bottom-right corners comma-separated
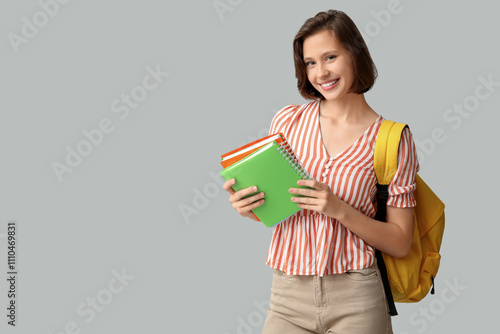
(289, 180, 345, 218)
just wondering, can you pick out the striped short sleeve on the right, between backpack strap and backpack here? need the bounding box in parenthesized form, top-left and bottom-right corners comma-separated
(387, 127, 420, 208)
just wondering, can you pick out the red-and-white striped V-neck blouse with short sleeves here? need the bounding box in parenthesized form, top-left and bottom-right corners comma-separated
(266, 100, 419, 276)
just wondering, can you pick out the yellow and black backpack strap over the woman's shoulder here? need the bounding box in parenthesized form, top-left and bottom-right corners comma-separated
(373, 120, 406, 316)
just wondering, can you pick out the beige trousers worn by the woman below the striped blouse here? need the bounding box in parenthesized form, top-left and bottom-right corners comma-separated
(262, 264, 392, 334)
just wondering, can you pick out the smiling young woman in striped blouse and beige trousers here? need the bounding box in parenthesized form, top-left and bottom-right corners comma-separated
(224, 10, 419, 334)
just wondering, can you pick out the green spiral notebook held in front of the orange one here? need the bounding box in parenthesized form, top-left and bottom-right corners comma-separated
(221, 141, 311, 227)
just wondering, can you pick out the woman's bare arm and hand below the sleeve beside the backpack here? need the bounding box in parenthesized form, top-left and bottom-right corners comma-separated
(290, 180, 413, 257)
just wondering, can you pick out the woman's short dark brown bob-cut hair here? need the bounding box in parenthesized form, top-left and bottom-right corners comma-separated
(293, 9, 377, 100)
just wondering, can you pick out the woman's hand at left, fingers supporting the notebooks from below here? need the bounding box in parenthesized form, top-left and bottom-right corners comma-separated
(222, 179, 264, 221)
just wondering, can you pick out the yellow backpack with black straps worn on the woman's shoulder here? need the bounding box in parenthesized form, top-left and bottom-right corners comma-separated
(374, 120, 444, 315)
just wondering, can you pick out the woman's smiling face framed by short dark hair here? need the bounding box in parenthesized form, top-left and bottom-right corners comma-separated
(302, 30, 354, 101)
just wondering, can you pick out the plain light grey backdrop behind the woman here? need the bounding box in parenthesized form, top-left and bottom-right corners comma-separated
(0, 0, 500, 334)
